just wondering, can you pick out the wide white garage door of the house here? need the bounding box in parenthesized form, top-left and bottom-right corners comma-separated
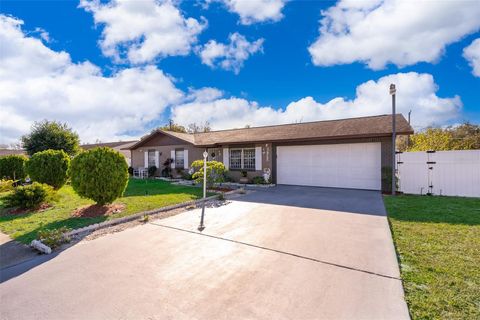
(277, 142, 381, 190)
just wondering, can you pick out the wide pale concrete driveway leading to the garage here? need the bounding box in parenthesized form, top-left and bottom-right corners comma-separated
(0, 186, 409, 319)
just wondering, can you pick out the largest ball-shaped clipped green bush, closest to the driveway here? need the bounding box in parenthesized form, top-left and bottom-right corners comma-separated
(70, 147, 128, 205)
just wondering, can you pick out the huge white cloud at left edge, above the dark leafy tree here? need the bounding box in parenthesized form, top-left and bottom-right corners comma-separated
(0, 15, 183, 144)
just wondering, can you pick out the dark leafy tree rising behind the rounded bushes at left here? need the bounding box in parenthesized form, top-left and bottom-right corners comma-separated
(22, 120, 80, 156)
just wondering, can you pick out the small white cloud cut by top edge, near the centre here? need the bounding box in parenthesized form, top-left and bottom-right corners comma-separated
(207, 0, 286, 25)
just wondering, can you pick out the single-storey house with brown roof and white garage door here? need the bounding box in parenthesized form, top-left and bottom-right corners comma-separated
(129, 114, 413, 191)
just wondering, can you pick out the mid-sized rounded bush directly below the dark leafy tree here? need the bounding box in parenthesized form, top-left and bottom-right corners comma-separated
(25, 150, 70, 189)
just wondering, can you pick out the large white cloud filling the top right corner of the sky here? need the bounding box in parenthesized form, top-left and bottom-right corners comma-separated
(308, 0, 480, 69)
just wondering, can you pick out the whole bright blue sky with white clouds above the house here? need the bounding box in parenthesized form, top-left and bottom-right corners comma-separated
(0, 0, 480, 143)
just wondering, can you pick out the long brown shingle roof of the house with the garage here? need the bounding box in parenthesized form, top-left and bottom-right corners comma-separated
(130, 114, 413, 149)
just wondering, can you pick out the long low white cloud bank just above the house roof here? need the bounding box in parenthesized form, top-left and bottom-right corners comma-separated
(172, 72, 462, 129)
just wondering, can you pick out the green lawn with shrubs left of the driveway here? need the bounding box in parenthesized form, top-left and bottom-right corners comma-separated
(0, 179, 202, 243)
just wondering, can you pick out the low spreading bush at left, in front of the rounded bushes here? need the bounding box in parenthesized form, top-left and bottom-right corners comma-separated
(4, 182, 54, 209)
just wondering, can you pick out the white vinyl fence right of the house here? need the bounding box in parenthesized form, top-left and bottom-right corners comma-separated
(397, 150, 480, 197)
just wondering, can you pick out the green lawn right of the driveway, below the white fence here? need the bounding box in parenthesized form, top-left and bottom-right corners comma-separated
(384, 195, 480, 319)
